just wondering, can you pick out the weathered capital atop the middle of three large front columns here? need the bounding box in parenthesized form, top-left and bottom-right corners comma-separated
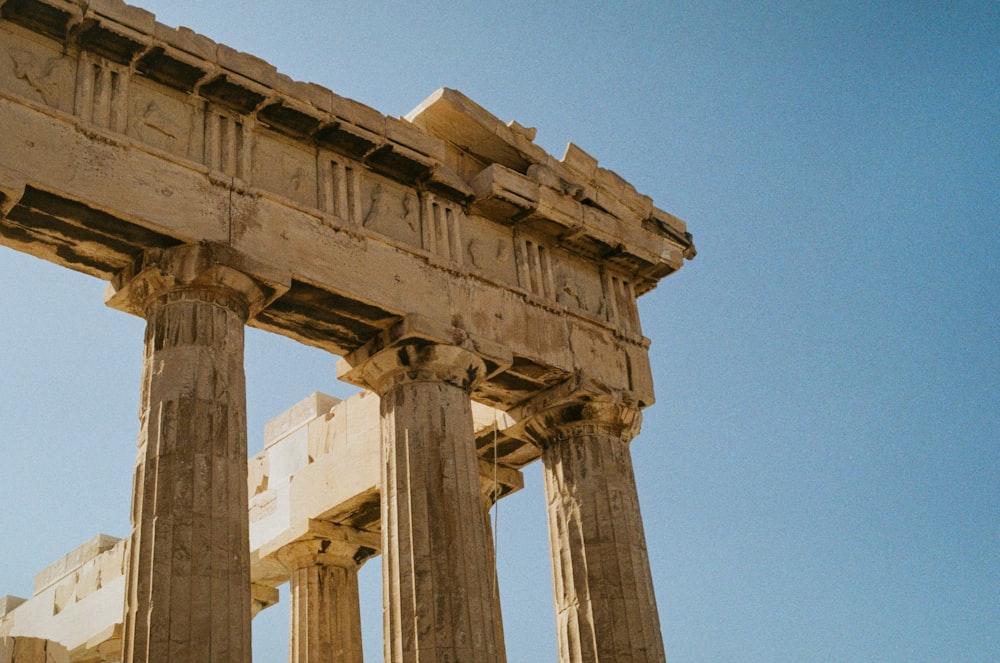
(337, 315, 512, 395)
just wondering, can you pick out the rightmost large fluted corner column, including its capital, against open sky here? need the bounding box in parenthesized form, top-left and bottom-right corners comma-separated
(517, 382, 664, 663)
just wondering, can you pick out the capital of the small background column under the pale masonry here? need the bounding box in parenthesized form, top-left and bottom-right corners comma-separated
(274, 523, 381, 572)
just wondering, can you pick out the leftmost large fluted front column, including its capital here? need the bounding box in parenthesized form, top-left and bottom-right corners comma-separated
(108, 244, 288, 663)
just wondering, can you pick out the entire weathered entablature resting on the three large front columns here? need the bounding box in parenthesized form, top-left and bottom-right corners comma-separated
(0, 0, 693, 430)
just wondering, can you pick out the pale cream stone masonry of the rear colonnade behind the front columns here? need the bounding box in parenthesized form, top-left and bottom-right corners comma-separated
(0, 392, 524, 663)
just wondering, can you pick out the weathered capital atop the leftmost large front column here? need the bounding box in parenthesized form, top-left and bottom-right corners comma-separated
(104, 242, 291, 319)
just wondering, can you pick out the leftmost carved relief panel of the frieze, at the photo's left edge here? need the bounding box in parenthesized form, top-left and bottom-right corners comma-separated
(0, 24, 75, 113)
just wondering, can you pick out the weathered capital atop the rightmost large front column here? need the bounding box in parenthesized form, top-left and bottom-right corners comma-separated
(504, 375, 642, 449)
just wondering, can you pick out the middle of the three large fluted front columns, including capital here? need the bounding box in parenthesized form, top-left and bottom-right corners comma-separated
(338, 320, 502, 663)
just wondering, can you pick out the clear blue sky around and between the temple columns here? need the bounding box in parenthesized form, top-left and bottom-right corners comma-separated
(0, 0, 1000, 663)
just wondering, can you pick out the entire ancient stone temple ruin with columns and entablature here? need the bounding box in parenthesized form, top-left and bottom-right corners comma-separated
(0, 0, 694, 663)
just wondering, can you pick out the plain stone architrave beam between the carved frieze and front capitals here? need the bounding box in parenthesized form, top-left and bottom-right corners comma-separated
(0, 98, 653, 407)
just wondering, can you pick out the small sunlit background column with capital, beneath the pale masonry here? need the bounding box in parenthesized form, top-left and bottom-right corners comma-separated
(277, 528, 377, 663)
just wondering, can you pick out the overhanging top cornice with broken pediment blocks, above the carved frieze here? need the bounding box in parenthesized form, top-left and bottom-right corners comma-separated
(0, 0, 694, 293)
